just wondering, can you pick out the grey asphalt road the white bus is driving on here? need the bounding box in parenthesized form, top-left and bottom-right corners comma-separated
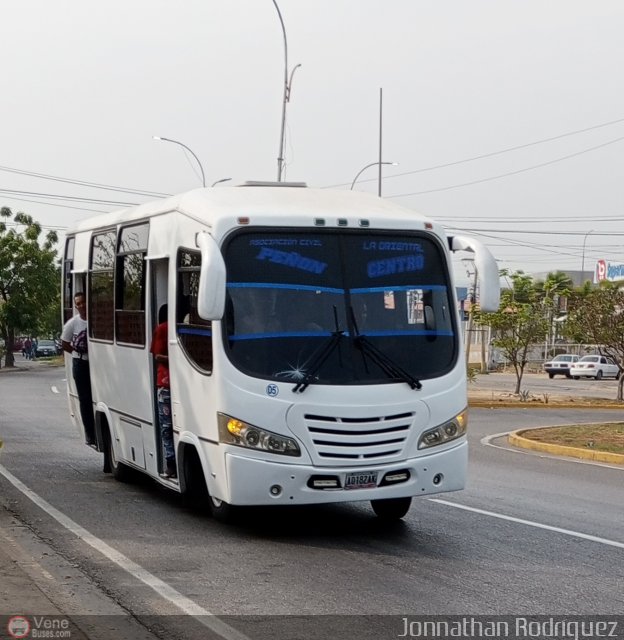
(0, 368, 624, 640)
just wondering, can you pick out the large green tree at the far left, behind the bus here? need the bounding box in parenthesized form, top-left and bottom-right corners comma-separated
(0, 207, 60, 367)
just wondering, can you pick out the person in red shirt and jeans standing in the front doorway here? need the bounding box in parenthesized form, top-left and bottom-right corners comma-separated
(150, 304, 177, 478)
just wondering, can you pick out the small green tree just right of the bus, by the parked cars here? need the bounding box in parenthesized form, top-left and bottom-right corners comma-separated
(475, 270, 549, 394)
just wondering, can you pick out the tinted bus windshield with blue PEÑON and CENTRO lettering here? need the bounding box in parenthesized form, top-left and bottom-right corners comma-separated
(222, 229, 459, 388)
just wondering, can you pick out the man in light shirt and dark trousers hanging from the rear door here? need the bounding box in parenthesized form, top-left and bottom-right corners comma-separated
(61, 291, 95, 445)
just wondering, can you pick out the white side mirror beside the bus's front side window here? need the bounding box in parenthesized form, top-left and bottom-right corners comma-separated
(195, 233, 225, 320)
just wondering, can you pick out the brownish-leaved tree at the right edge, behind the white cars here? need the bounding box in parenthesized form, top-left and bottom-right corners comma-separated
(565, 281, 624, 401)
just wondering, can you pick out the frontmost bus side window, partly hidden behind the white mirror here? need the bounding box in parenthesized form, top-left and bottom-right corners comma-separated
(176, 249, 212, 373)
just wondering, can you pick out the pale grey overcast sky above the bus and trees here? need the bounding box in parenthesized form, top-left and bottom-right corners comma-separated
(0, 0, 624, 283)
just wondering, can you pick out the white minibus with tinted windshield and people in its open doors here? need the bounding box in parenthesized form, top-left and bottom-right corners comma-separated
(63, 183, 499, 520)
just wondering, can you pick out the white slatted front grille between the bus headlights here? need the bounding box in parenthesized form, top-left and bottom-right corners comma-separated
(304, 412, 415, 460)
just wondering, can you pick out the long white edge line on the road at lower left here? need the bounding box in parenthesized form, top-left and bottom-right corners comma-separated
(0, 465, 251, 640)
